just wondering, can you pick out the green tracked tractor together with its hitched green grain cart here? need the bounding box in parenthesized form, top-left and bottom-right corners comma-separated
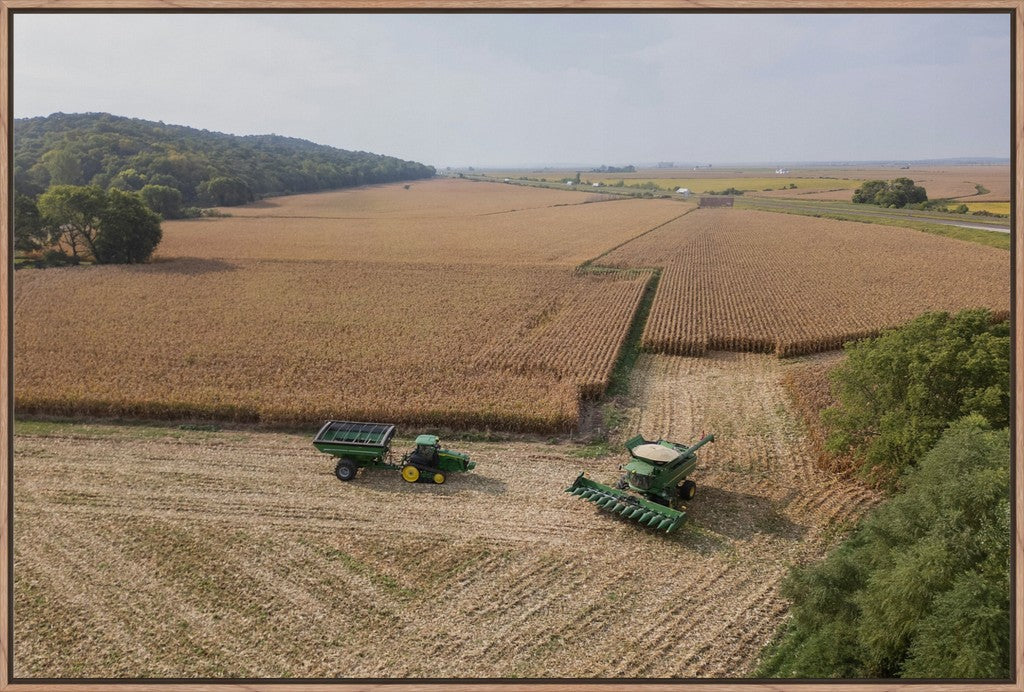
(313, 421, 476, 483)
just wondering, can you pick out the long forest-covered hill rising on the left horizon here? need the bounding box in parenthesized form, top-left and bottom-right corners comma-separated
(13, 113, 434, 205)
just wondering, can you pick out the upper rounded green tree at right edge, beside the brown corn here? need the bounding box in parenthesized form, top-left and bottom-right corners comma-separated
(822, 310, 1010, 484)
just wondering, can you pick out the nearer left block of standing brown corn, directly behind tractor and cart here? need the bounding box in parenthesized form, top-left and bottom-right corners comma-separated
(14, 260, 648, 431)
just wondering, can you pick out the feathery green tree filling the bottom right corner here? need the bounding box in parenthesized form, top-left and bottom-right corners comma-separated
(757, 415, 1011, 678)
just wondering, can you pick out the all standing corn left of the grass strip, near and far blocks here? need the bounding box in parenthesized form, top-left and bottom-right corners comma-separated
(14, 180, 693, 432)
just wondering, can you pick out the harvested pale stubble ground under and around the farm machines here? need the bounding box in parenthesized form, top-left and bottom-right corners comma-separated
(14, 354, 873, 678)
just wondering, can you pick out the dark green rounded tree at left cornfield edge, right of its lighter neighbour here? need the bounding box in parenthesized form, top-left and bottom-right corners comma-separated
(95, 189, 162, 264)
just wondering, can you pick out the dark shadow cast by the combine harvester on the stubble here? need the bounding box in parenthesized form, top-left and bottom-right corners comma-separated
(686, 485, 807, 540)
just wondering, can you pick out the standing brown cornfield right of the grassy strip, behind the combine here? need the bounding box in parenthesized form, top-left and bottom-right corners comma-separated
(600, 209, 1010, 355)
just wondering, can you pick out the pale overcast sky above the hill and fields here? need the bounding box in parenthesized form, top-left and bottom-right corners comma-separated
(13, 13, 1010, 167)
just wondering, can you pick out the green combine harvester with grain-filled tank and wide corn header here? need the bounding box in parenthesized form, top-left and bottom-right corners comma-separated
(565, 435, 715, 533)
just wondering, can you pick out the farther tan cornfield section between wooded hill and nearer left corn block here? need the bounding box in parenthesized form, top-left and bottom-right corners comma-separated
(156, 180, 695, 269)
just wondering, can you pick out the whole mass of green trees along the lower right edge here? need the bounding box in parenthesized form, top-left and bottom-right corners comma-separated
(756, 310, 1012, 679)
